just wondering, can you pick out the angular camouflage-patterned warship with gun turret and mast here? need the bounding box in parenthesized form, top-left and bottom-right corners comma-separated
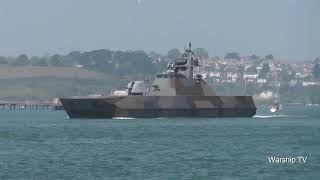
(60, 43, 256, 118)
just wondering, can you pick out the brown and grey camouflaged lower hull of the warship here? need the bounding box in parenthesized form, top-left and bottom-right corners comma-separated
(60, 96, 256, 119)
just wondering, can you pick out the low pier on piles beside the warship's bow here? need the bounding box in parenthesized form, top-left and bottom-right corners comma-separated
(0, 99, 63, 111)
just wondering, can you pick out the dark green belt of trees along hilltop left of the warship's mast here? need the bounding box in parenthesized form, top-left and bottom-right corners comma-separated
(0, 49, 165, 75)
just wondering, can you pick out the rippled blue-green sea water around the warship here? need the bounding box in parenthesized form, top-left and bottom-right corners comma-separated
(0, 106, 320, 180)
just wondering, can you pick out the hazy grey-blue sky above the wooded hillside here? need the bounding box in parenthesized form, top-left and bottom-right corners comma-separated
(0, 0, 320, 60)
